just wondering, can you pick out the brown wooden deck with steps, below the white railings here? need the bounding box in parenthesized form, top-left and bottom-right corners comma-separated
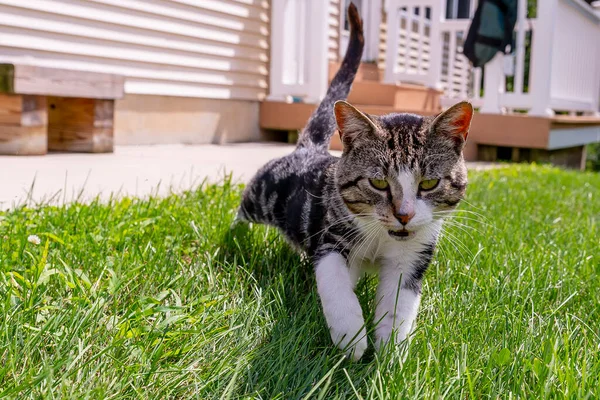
(260, 63, 600, 168)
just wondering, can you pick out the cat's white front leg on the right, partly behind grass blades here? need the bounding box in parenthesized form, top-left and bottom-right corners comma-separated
(375, 265, 421, 349)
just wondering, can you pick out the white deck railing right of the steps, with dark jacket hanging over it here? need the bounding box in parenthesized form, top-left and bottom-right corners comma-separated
(385, 0, 600, 116)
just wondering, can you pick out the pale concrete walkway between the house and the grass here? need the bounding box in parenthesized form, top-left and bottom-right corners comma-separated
(0, 143, 496, 210)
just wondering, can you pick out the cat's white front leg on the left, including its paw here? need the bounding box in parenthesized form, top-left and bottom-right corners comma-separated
(315, 252, 367, 360)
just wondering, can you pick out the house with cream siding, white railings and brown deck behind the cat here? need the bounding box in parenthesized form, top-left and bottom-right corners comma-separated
(0, 0, 600, 167)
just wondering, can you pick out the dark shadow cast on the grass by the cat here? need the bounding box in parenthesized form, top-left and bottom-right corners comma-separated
(213, 223, 374, 399)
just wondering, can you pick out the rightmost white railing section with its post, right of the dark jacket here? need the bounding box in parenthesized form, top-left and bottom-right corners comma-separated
(482, 0, 600, 116)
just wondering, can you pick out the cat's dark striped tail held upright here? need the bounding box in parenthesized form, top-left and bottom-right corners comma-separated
(297, 3, 365, 151)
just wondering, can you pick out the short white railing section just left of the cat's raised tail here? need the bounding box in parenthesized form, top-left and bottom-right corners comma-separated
(268, 0, 329, 103)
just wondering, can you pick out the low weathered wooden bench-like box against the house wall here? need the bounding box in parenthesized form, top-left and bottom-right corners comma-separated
(0, 64, 124, 155)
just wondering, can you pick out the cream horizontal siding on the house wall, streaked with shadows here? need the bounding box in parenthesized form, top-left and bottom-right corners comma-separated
(0, 0, 270, 100)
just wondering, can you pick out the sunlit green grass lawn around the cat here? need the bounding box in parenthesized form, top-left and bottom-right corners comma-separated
(0, 166, 600, 399)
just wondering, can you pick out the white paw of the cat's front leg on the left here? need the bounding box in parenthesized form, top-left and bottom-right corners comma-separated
(329, 315, 368, 361)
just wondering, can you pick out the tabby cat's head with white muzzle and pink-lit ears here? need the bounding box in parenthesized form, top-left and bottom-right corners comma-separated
(335, 101, 473, 240)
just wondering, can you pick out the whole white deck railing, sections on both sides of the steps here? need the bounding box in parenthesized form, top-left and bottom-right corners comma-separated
(269, 0, 600, 116)
